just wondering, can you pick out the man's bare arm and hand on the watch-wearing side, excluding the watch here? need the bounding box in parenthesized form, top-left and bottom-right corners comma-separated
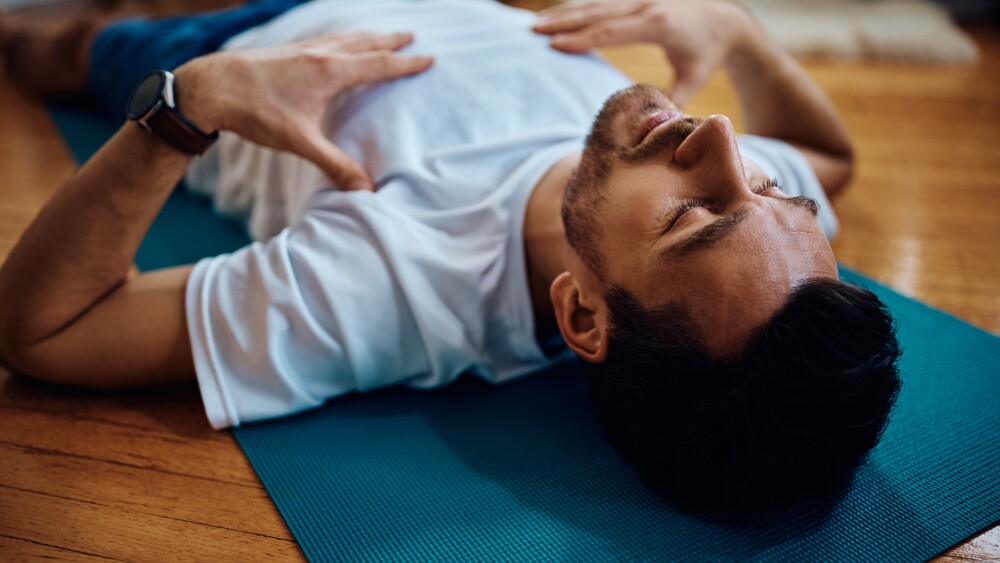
(0, 33, 431, 387)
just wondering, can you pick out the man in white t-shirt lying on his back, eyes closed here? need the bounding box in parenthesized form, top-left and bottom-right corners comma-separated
(0, 0, 899, 508)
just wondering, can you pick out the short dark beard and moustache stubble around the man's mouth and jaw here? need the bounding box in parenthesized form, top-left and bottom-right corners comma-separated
(562, 84, 702, 280)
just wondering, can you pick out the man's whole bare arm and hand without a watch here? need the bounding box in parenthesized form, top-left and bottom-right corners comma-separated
(534, 0, 853, 195)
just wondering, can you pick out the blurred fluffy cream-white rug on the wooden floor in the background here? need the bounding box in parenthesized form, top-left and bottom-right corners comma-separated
(738, 0, 978, 64)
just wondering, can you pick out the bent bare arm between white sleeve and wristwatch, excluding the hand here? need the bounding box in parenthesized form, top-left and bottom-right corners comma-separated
(0, 125, 194, 386)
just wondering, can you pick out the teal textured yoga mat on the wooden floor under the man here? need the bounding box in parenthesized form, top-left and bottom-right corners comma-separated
(52, 102, 1000, 561)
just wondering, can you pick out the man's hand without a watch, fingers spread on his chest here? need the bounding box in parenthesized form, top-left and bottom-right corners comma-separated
(533, 0, 753, 106)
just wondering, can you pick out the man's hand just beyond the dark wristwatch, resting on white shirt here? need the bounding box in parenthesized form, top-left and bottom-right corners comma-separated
(174, 32, 433, 190)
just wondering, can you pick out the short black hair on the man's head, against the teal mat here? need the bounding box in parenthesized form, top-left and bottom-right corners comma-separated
(588, 279, 900, 512)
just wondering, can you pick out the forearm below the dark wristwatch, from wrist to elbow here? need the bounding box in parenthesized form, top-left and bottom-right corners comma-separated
(0, 123, 191, 348)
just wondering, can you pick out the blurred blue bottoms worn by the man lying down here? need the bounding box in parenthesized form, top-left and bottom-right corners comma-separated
(87, 0, 306, 121)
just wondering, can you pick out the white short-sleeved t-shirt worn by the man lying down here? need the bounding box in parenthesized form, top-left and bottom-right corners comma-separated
(186, 0, 832, 428)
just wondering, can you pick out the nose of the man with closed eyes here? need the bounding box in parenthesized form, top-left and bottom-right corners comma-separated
(674, 115, 752, 202)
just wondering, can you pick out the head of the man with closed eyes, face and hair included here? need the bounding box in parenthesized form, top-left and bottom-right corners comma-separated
(551, 86, 899, 505)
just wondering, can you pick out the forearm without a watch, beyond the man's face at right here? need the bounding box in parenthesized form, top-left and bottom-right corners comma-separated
(725, 8, 852, 159)
